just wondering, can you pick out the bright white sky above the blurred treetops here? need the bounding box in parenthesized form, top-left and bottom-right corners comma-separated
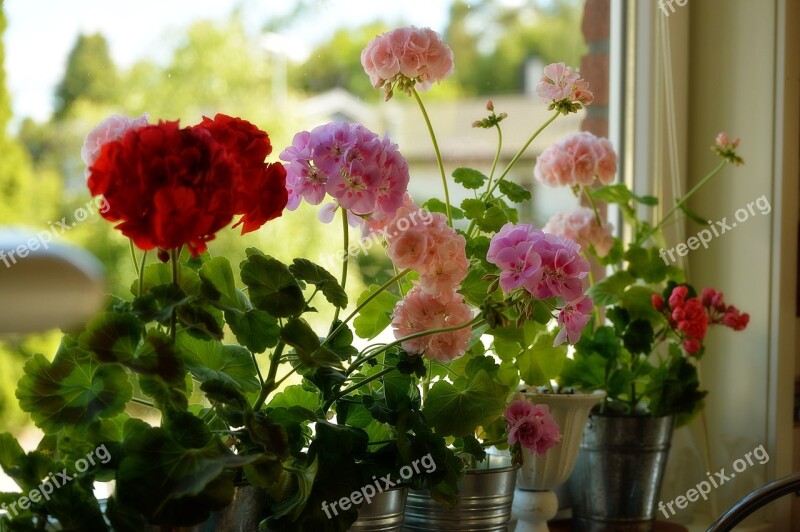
(3, 0, 450, 121)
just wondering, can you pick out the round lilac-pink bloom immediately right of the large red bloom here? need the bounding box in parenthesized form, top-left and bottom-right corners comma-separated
(280, 122, 409, 224)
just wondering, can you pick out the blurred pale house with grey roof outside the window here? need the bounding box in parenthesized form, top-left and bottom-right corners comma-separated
(298, 89, 583, 225)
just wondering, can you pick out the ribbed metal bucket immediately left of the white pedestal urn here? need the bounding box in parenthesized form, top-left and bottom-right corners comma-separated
(403, 456, 519, 532)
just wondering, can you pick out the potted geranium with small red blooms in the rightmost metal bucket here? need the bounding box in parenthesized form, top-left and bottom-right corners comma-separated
(535, 133, 748, 526)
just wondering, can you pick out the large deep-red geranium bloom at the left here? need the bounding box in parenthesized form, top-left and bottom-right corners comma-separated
(87, 114, 288, 255)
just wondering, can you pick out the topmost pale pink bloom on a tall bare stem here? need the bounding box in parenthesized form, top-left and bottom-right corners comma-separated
(361, 26, 453, 100)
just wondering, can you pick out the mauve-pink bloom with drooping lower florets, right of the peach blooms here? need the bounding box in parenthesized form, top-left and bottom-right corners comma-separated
(486, 223, 592, 345)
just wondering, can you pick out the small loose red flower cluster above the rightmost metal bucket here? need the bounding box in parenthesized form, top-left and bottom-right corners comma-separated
(652, 285, 750, 355)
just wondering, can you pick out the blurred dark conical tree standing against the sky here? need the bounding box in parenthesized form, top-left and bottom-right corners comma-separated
(55, 33, 119, 118)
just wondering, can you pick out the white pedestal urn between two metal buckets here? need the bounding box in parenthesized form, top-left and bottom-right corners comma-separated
(514, 392, 605, 532)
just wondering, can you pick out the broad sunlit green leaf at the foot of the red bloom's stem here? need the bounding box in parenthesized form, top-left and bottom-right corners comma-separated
(177, 334, 261, 394)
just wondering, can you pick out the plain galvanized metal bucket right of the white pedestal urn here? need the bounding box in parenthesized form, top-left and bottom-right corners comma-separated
(570, 415, 675, 532)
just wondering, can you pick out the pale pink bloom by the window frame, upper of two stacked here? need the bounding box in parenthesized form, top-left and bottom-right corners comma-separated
(533, 131, 617, 187)
